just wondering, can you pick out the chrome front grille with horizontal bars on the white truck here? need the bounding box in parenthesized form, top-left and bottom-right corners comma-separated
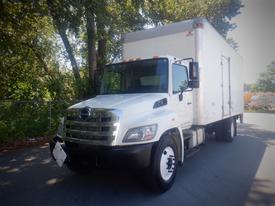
(65, 108, 118, 144)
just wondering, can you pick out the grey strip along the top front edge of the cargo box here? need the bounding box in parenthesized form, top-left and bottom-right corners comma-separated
(123, 18, 207, 43)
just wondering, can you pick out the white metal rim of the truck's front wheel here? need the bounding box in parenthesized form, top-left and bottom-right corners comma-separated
(160, 146, 175, 181)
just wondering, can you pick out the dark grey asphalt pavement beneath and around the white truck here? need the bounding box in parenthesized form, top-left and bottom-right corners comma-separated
(0, 114, 275, 206)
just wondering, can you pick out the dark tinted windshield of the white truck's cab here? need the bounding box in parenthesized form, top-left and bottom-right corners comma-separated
(100, 58, 168, 94)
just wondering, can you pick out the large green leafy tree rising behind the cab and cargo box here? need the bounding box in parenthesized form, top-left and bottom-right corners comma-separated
(47, 0, 242, 98)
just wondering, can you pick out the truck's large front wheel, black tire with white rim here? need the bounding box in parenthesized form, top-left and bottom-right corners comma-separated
(147, 135, 178, 193)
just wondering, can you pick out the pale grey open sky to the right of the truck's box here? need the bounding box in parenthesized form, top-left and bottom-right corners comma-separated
(229, 0, 275, 83)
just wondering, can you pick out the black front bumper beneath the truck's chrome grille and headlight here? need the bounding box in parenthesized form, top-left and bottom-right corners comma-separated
(50, 140, 153, 168)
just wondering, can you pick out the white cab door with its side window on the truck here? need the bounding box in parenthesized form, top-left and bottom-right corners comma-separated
(172, 64, 193, 129)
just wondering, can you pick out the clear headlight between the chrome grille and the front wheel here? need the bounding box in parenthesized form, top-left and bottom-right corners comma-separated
(122, 124, 157, 142)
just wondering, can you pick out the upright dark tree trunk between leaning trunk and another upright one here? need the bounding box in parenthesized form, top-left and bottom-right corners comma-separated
(86, 8, 97, 95)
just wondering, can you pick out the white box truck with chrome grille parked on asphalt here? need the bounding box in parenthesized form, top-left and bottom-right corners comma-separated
(50, 18, 243, 192)
